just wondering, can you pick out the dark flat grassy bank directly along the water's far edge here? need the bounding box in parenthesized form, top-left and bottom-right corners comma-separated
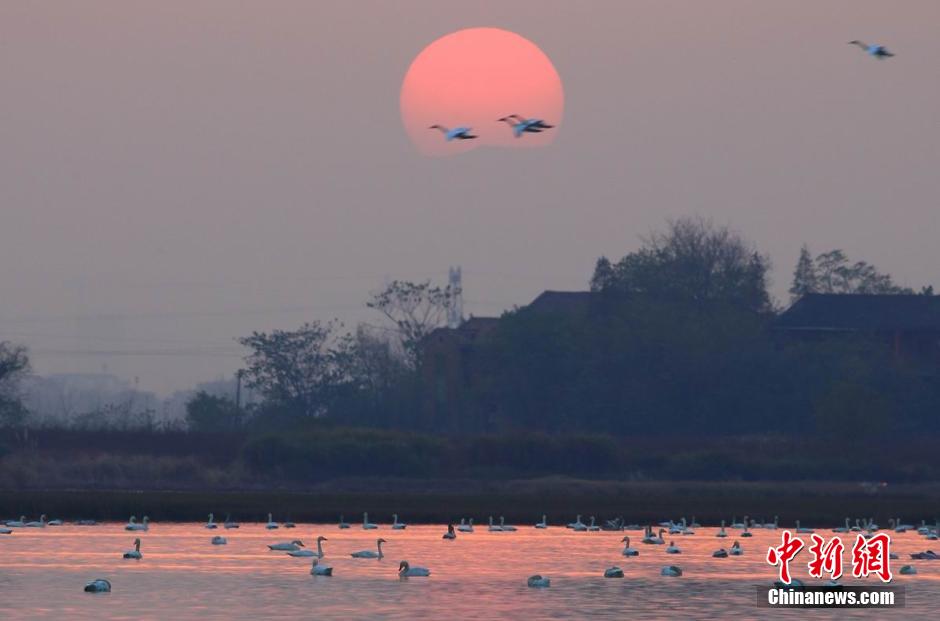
(0, 478, 940, 525)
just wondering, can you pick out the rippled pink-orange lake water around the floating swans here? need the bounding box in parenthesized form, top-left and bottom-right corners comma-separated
(0, 524, 940, 621)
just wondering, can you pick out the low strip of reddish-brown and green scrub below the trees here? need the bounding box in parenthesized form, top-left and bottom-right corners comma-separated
(0, 423, 940, 490)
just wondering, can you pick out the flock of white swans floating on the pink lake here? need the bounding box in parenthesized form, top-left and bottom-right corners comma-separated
(0, 513, 940, 593)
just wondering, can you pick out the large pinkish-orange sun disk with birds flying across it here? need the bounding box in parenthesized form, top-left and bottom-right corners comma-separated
(401, 28, 564, 155)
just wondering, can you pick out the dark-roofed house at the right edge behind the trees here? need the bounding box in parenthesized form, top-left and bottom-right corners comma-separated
(774, 293, 940, 363)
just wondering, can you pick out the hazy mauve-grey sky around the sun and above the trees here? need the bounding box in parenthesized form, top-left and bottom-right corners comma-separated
(0, 0, 940, 392)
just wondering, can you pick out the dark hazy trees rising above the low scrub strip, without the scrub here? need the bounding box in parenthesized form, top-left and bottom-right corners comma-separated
(0, 218, 940, 436)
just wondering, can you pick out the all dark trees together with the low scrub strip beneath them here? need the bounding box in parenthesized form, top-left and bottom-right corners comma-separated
(0, 220, 940, 490)
